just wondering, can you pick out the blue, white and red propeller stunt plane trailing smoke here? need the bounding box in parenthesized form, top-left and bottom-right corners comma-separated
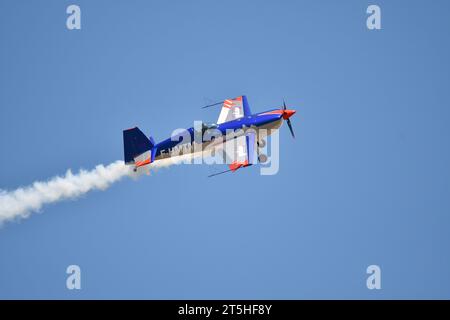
(123, 95, 295, 177)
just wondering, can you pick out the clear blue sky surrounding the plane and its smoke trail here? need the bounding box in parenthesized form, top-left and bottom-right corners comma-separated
(0, 0, 450, 299)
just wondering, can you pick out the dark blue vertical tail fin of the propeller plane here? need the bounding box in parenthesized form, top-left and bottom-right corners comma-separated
(123, 127, 155, 164)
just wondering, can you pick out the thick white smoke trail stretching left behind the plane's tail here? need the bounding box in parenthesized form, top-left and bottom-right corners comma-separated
(0, 161, 132, 225)
